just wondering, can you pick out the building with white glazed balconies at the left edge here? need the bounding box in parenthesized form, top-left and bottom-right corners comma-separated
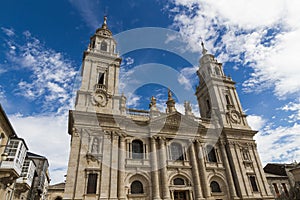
(0, 105, 49, 200)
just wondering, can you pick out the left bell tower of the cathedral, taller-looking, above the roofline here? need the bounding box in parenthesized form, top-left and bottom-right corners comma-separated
(75, 17, 126, 114)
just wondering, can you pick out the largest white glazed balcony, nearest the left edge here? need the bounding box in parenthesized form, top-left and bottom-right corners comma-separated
(0, 138, 27, 184)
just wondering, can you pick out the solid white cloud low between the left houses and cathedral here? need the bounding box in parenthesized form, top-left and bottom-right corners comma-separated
(9, 114, 70, 184)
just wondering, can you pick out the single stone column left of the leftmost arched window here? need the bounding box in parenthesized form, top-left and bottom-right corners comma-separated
(118, 136, 126, 200)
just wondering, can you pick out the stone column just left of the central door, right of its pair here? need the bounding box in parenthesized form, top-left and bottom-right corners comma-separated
(159, 138, 171, 200)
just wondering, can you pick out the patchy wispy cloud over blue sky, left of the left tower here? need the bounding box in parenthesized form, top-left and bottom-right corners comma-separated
(2, 31, 77, 112)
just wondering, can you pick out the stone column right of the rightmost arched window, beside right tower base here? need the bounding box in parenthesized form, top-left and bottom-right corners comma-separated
(221, 142, 236, 199)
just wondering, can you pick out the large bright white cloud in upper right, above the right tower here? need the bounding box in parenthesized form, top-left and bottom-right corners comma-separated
(169, 0, 300, 98)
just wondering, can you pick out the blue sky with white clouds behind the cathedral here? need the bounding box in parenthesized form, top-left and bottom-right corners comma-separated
(0, 0, 300, 183)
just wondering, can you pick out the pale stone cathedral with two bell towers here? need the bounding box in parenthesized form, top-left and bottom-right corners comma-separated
(63, 18, 274, 200)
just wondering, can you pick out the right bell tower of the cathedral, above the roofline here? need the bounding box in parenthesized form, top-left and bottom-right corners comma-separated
(196, 42, 250, 129)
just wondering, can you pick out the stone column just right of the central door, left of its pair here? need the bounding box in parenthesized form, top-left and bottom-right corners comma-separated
(189, 141, 203, 199)
